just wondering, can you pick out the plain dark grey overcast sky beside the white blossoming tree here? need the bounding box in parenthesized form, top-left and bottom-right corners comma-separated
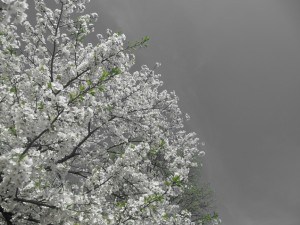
(88, 0, 300, 225)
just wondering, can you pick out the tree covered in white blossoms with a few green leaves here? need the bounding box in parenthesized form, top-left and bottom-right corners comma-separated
(0, 0, 220, 225)
